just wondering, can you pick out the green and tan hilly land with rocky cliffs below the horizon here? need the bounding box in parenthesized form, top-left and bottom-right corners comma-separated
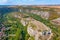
(0, 6, 60, 40)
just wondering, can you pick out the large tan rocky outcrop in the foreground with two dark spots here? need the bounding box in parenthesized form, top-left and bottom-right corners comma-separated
(27, 20, 52, 40)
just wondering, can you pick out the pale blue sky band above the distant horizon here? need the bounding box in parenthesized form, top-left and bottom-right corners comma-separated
(0, 0, 60, 5)
